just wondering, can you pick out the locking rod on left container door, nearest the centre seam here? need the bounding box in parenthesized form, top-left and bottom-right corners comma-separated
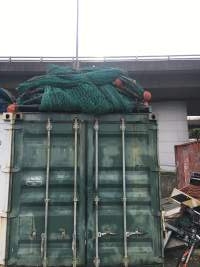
(72, 118, 79, 267)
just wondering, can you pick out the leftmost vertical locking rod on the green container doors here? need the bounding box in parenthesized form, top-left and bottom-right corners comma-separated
(42, 118, 52, 267)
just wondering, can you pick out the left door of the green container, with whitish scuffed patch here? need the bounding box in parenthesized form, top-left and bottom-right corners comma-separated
(7, 117, 85, 266)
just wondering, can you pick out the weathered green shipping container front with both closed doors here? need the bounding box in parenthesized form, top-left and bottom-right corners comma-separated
(4, 113, 163, 267)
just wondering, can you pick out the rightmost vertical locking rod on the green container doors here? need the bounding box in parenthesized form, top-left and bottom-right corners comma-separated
(121, 118, 128, 267)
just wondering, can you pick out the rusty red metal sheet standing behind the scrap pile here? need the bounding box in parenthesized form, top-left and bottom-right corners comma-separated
(175, 142, 200, 189)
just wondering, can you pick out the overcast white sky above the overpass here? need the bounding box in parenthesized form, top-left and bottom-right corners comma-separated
(0, 0, 200, 56)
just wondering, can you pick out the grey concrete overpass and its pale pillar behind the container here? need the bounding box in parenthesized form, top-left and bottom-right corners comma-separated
(0, 56, 200, 195)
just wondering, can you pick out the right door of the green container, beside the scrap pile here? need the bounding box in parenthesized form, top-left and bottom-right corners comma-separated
(87, 116, 162, 267)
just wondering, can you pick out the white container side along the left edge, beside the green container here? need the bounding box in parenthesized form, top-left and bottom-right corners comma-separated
(0, 118, 13, 265)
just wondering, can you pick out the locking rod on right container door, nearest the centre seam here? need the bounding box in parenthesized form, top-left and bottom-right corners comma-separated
(94, 120, 100, 267)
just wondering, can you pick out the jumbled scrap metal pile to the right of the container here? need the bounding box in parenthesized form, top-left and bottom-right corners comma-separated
(164, 173, 200, 267)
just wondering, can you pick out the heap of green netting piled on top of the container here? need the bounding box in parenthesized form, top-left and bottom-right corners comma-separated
(17, 65, 144, 114)
